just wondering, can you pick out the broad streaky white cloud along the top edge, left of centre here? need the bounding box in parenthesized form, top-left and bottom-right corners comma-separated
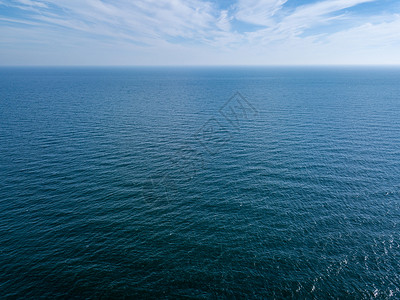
(40, 0, 217, 38)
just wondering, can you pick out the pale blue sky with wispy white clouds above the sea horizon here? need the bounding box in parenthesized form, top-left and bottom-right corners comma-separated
(0, 0, 400, 66)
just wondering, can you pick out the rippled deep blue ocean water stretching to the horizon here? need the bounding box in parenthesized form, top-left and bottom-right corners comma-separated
(0, 67, 400, 299)
